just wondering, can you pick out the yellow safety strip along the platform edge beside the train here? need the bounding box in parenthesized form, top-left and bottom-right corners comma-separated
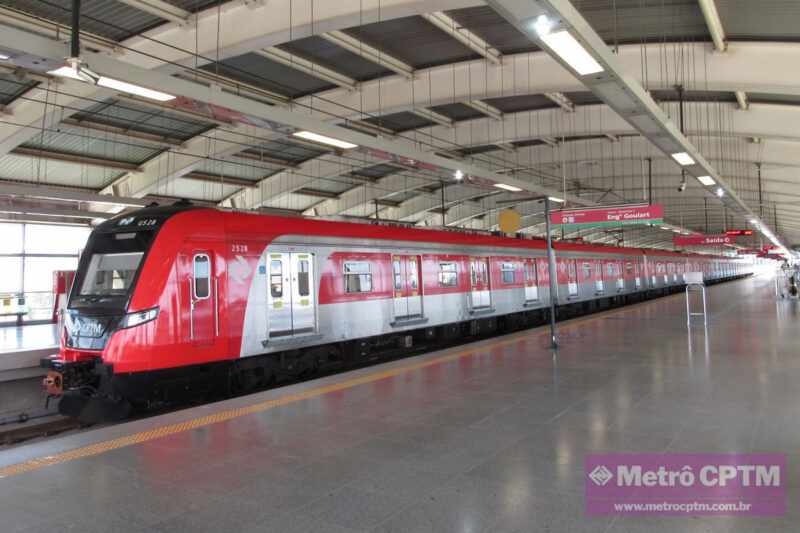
(0, 286, 682, 479)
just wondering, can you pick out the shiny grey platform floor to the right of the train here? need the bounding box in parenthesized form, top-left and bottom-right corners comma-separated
(0, 277, 800, 533)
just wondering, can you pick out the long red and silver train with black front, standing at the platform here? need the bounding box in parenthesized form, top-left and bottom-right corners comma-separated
(42, 205, 750, 417)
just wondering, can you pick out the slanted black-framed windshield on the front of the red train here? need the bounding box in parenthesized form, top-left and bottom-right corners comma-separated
(69, 231, 155, 310)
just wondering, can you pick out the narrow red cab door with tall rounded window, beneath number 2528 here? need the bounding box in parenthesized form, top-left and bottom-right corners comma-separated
(183, 248, 219, 346)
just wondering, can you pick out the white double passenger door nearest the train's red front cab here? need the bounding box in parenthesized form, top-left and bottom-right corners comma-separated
(267, 252, 316, 337)
